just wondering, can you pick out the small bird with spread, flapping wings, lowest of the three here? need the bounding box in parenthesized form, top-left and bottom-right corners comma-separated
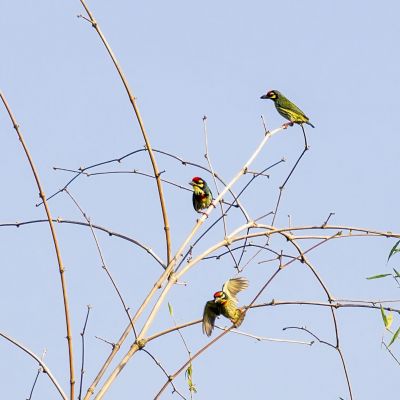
(203, 277, 249, 336)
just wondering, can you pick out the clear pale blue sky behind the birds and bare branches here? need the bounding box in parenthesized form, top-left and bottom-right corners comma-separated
(0, 0, 400, 400)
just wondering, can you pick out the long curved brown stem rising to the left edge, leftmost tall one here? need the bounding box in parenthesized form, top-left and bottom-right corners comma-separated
(0, 92, 75, 400)
